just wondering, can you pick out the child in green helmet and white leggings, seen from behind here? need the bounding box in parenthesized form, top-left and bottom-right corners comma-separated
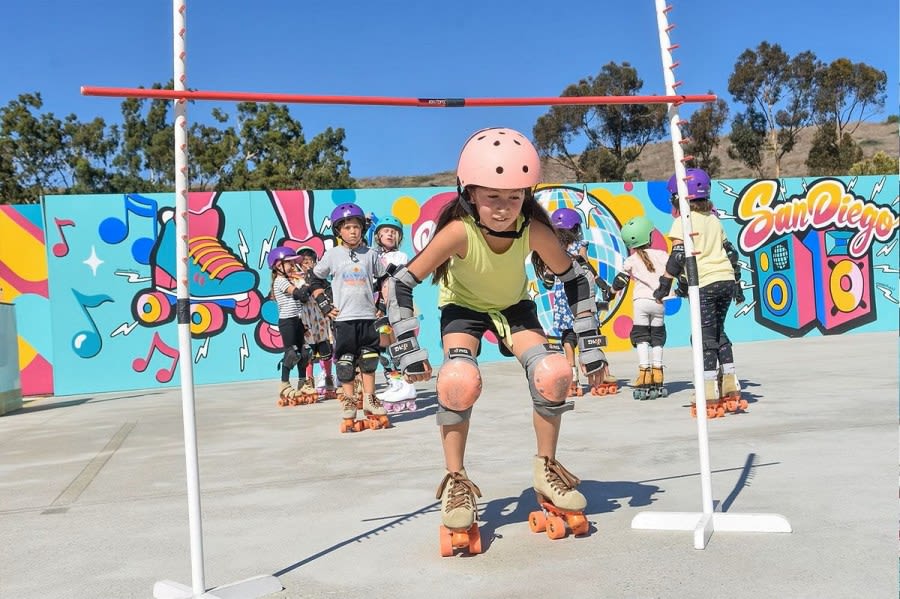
(612, 216, 669, 399)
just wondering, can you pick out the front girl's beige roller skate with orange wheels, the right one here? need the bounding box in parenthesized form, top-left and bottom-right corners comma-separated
(528, 456, 590, 539)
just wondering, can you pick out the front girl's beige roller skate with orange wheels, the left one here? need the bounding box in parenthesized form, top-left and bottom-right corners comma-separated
(435, 468, 481, 557)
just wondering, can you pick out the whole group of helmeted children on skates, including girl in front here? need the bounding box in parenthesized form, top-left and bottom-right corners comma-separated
(269, 128, 744, 555)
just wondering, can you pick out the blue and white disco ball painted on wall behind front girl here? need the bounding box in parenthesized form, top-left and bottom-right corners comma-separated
(528, 186, 628, 336)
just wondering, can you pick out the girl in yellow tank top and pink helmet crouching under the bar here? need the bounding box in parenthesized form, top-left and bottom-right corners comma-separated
(376, 128, 606, 555)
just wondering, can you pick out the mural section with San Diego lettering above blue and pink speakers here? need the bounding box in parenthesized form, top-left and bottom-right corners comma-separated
(736, 177, 898, 337)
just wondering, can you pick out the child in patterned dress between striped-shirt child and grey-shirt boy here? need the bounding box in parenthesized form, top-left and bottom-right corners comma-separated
(297, 246, 336, 399)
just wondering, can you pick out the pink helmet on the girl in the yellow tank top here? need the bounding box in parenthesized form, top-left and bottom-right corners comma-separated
(456, 127, 541, 189)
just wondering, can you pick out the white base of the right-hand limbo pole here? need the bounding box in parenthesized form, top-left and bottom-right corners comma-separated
(631, 512, 791, 549)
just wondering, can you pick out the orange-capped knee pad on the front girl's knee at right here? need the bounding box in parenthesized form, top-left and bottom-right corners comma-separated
(521, 344, 575, 417)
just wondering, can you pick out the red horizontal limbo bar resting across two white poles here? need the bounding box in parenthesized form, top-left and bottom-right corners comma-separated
(81, 85, 716, 108)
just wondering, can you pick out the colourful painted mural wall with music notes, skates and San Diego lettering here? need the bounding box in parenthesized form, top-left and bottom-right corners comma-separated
(0, 176, 900, 395)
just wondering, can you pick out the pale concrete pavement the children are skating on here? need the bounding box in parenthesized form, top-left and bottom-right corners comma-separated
(0, 332, 898, 599)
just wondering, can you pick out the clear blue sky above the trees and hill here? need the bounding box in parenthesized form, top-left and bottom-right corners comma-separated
(0, 0, 900, 177)
